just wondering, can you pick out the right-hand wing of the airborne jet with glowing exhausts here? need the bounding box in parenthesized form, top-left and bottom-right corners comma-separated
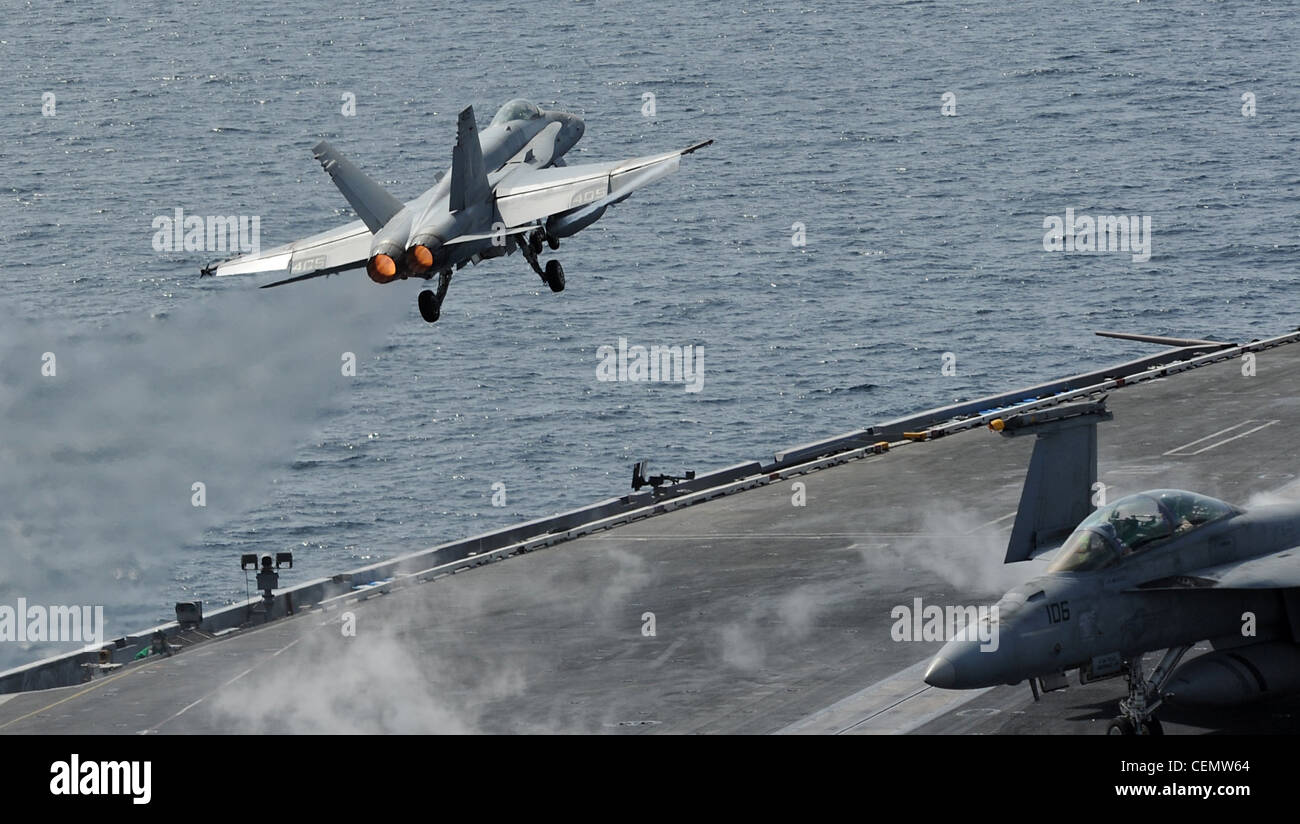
(495, 140, 712, 227)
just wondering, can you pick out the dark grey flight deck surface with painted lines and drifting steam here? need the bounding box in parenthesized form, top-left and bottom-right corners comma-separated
(0, 346, 1300, 734)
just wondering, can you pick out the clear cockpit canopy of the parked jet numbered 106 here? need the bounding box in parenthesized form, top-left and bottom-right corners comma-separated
(1048, 489, 1236, 572)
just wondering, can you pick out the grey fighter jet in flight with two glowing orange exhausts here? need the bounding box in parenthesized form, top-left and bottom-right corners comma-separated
(202, 99, 712, 324)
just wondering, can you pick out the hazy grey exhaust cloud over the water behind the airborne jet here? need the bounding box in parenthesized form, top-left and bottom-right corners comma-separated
(0, 279, 410, 667)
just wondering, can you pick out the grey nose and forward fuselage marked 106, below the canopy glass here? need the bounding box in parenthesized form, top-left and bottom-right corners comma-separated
(926, 504, 1300, 689)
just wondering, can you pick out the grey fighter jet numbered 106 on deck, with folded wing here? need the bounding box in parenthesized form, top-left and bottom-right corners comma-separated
(924, 400, 1300, 734)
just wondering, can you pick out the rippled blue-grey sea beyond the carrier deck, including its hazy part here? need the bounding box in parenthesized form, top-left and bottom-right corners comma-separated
(0, 1, 1300, 665)
